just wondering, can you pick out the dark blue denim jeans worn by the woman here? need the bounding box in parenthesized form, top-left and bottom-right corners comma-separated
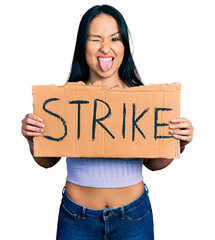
(57, 185, 154, 240)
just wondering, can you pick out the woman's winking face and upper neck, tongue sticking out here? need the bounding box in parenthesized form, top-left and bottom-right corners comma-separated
(85, 14, 124, 79)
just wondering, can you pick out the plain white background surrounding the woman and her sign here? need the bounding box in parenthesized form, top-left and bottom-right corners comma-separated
(0, 0, 215, 240)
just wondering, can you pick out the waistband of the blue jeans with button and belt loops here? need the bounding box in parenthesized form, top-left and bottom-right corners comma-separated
(62, 184, 148, 218)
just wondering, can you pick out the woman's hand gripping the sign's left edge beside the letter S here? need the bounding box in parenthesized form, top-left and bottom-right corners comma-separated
(22, 113, 45, 141)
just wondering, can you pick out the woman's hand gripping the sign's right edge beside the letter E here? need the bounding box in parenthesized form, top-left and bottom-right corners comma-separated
(170, 118, 194, 149)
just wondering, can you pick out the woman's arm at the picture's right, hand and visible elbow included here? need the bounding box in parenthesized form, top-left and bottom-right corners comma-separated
(143, 118, 194, 171)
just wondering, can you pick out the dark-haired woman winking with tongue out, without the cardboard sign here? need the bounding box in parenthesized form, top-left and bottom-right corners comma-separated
(22, 5, 193, 240)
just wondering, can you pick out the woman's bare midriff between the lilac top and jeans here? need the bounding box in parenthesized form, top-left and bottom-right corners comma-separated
(66, 181, 144, 209)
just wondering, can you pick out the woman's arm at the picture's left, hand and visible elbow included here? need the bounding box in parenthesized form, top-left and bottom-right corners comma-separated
(22, 113, 61, 168)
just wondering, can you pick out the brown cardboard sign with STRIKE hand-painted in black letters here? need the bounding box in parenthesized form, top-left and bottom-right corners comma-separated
(33, 82, 181, 158)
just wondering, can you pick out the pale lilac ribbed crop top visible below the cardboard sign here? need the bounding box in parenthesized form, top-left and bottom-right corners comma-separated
(66, 157, 143, 188)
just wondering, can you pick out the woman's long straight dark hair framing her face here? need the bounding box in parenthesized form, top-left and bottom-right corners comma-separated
(68, 5, 143, 87)
